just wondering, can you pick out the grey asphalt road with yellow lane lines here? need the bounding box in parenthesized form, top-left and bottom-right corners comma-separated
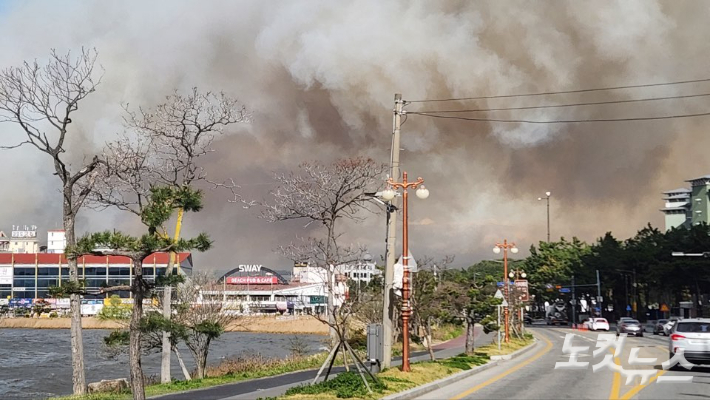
(419, 326, 710, 400)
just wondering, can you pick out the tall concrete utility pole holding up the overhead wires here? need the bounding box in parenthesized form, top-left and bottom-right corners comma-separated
(381, 93, 406, 368)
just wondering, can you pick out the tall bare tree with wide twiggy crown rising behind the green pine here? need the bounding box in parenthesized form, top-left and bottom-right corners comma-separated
(92, 88, 251, 383)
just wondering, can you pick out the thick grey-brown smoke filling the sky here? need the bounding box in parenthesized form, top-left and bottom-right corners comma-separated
(0, 0, 710, 270)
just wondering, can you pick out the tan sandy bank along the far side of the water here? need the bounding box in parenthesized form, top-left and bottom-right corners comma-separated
(0, 316, 328, 335)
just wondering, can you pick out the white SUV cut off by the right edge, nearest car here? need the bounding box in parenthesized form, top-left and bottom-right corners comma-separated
(668, 318, 710, 365)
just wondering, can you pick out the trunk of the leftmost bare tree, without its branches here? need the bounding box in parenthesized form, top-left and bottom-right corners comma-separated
(62, 197, 86, 395)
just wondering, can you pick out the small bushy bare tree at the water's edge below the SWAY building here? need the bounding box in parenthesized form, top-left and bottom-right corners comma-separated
(175, 273, 237, 379)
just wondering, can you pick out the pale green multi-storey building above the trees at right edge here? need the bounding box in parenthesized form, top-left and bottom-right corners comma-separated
(661, 175, 710, 230)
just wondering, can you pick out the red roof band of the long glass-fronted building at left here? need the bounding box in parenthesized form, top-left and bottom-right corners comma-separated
(0, 253, 191, 265)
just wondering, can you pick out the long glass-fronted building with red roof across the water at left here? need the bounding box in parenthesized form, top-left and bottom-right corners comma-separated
(0, 253, 192, 299)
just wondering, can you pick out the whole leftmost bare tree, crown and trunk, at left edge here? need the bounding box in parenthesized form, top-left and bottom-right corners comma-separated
(0, 49, 101, 394)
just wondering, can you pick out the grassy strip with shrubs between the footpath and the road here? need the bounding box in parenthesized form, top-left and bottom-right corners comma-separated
(277, 335, 533, 400)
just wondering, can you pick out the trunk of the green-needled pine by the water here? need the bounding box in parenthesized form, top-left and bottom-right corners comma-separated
(128, 258, 145, 400)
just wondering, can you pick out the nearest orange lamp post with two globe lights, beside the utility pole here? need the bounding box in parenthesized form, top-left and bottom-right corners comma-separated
(382, 172, 429, 372)
